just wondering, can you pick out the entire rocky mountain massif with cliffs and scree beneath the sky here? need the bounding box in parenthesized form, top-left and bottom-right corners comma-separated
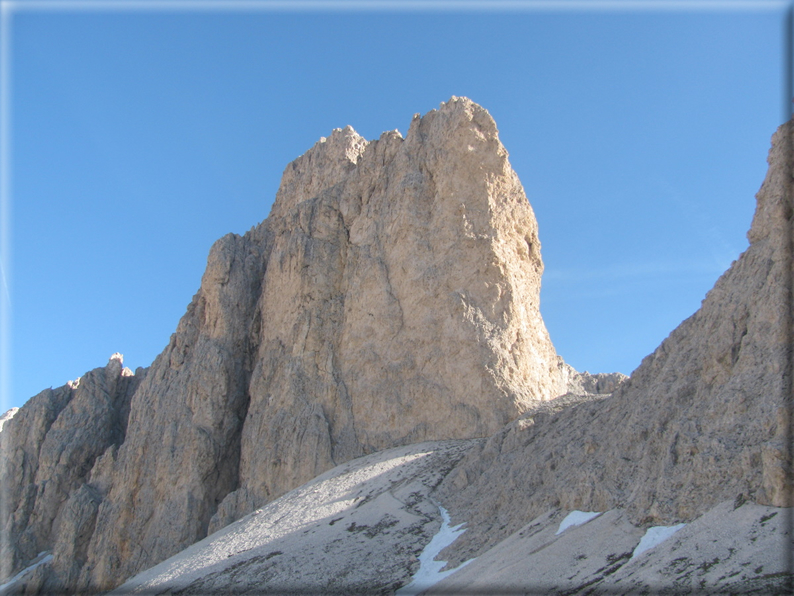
(0, 97, 794, 594)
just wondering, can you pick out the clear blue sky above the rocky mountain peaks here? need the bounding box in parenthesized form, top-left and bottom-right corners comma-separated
(2, 1, 787, 407)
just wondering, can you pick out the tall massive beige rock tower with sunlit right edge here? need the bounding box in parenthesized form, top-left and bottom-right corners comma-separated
(221, 99, 564, 513)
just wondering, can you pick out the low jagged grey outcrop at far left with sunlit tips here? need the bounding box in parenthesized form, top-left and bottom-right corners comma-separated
(0, 354, 146, 585)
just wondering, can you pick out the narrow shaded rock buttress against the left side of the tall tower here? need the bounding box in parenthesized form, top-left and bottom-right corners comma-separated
(78, 229, 264, 589)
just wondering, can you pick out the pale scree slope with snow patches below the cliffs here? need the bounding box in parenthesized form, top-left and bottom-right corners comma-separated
(111, 439, 791, 596)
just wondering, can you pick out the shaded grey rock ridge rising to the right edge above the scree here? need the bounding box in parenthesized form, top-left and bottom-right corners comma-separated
(440, 117, 794, 561)
